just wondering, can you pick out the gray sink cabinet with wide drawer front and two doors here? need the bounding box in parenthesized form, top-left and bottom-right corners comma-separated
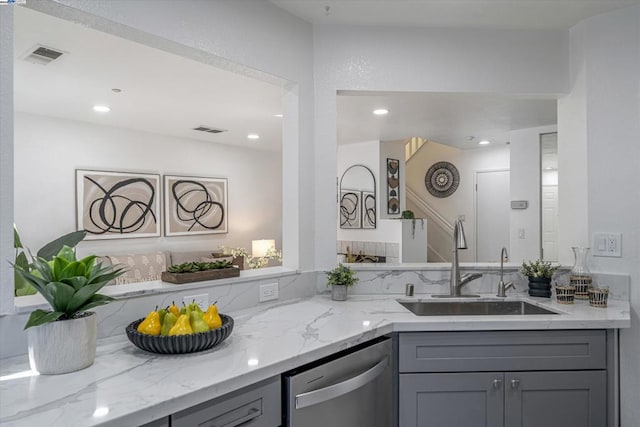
(398, 331, 607, 427)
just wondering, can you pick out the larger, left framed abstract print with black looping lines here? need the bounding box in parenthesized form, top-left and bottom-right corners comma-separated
(76, 170, 160, 240)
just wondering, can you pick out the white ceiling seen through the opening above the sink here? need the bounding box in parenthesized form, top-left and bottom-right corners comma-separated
(337, 92, 557, 149)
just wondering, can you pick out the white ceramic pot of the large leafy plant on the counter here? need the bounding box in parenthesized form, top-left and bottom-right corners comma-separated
(27, 312, 98, 374)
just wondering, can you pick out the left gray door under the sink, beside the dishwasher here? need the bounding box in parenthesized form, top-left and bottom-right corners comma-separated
(398, 372, 504, 427)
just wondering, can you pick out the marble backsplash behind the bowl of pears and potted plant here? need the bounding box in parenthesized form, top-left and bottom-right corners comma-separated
(0, 272, 316, 359)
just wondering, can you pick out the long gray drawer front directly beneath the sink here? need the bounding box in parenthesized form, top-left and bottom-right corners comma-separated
(398, 330, 606, 372)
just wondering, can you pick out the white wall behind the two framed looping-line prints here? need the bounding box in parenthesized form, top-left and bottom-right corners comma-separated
(14, 113, 282, 254)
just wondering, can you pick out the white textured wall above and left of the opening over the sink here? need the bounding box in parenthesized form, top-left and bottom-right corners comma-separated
(314, 25, 568, 269)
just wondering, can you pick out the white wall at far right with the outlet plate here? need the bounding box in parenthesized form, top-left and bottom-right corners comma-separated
(558, 5, 640, 427)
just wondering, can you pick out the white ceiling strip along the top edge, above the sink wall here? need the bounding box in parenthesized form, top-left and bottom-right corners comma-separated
(271, 0, 640, 30)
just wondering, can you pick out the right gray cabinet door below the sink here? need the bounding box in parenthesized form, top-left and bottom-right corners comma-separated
(504, 371, 607, 427)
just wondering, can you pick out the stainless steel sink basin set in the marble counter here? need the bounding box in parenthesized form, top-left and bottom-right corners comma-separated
(398, 301, 558, 316)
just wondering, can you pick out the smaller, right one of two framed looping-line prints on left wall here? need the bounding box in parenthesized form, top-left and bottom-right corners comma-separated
(164, 175, 228, 236)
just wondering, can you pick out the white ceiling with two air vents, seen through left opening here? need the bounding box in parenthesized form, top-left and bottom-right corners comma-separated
(14, 7, 283, 151)
